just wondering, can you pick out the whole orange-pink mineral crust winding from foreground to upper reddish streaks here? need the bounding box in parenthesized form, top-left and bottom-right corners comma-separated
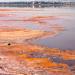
(0, 9, 75, 75)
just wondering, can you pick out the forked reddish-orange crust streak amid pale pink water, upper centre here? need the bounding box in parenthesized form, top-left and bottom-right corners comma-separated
(23, 16, 58, 26)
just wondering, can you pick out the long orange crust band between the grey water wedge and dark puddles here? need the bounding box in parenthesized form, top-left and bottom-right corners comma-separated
(0, 44, 75, 60)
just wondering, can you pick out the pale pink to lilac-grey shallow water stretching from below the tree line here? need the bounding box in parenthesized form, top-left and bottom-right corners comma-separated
(0, 8, 75, 50)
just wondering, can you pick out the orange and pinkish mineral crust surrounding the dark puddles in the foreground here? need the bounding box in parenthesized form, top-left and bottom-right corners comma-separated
(0, 44, 75, 75)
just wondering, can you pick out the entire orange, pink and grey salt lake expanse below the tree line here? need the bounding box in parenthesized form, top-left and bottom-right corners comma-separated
(0, 8, 75, 75)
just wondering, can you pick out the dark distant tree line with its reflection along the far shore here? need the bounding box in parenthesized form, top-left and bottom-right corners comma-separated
(0, 1, 75, 8)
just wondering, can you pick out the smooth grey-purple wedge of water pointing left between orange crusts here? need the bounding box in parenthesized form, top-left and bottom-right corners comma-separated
(31, 26, 75, 50)
